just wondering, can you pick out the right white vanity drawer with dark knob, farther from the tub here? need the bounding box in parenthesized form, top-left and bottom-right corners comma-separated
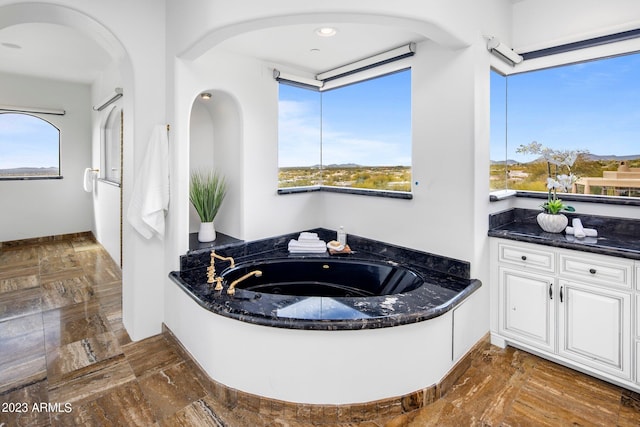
(559, 252, 633, 288)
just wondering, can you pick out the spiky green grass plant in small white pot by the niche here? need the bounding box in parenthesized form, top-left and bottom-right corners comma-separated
(189, 171, 227, 242)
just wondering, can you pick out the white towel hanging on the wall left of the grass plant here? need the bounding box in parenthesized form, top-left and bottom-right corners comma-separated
(127, 125, 169, 240)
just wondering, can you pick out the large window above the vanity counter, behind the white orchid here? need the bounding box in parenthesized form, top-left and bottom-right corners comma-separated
(490, 53, 640, 197)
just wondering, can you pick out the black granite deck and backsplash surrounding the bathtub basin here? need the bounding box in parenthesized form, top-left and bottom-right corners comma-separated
(169, 229, 481, 330)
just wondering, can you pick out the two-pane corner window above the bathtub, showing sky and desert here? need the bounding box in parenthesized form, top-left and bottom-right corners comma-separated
(278, 69, 411, 192)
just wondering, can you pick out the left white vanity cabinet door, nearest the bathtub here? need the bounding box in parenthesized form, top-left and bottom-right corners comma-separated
(498, 267, 555, 352)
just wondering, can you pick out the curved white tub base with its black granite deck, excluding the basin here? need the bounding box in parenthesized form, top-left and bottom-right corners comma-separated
(165, 229, 481, 405)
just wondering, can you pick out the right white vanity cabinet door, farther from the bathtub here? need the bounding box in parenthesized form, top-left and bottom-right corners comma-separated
(558, 280, 631, 379)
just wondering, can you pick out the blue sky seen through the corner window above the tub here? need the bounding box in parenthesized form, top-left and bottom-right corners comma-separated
(278, 70, 411, 167)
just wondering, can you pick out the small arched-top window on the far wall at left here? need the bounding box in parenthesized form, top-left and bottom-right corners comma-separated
(0, 113, 60, 179)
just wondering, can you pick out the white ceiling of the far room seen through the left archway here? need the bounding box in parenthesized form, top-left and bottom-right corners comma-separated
(0, 23, 112, 84)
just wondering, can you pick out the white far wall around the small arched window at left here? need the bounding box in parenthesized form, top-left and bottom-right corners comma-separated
(0, 74, 93, 241)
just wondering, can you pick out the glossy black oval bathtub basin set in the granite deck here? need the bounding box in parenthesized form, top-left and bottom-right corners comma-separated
(222, 258, 424, 297)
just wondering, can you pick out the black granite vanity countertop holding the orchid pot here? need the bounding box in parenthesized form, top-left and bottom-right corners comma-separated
(489, 208, 640, 260)
